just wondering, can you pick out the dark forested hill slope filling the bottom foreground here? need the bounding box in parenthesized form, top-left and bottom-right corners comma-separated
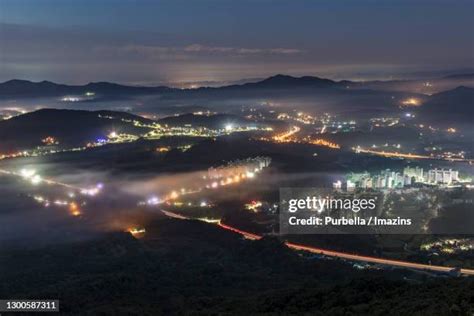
(0, 219, 474, 315)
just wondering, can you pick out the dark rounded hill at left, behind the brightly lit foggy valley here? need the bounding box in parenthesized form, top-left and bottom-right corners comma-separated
(0, 109, 154, 153)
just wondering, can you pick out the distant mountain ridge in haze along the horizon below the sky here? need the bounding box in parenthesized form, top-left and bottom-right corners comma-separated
(0, 74, 474, 98)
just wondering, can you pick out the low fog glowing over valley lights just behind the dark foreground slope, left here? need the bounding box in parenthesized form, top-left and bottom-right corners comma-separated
(0, 154, 340, 246)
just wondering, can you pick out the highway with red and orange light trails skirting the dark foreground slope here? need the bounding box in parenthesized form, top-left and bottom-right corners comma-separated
(163, 211, 474, 275)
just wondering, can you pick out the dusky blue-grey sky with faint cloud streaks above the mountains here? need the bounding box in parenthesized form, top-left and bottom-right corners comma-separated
(0, 0, 474, 84)
